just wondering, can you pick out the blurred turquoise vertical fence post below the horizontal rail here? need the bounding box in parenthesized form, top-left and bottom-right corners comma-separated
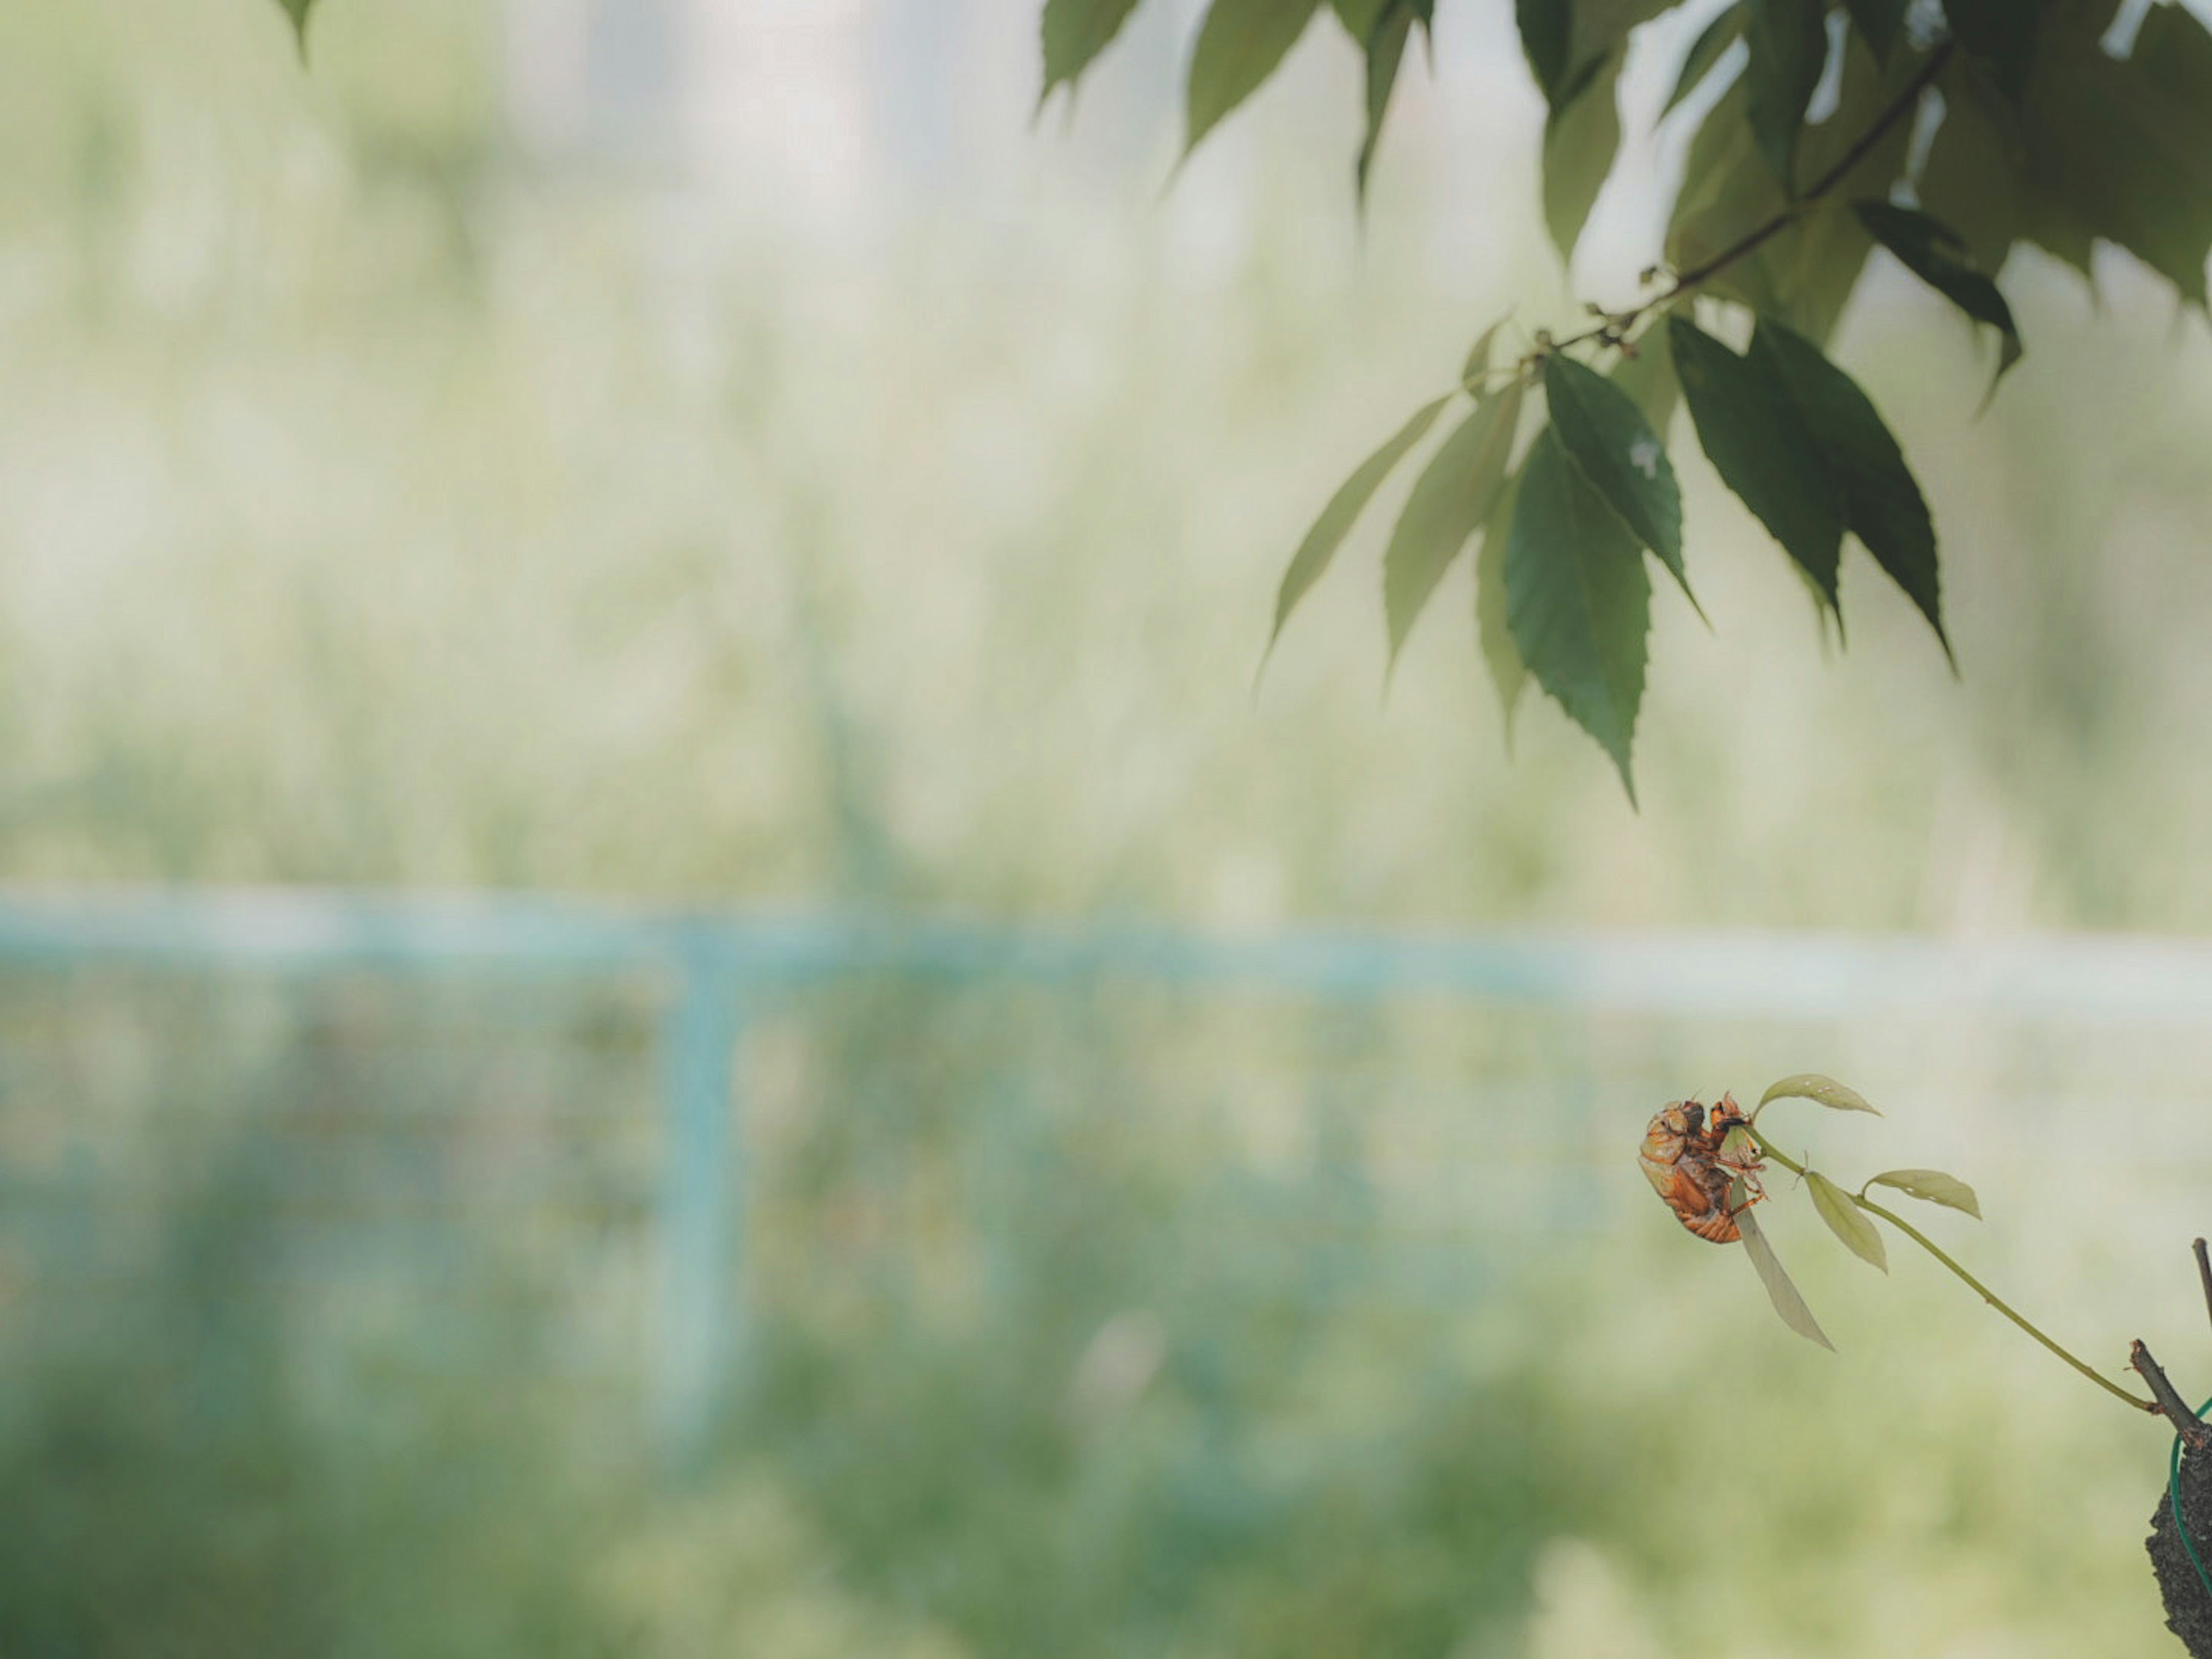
(653, 927, 743, 1464)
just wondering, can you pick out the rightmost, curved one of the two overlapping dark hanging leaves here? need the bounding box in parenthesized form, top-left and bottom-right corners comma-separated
(1752, 316, 1957, 668)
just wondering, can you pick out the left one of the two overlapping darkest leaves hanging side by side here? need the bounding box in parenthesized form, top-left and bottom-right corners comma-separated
(1668, 314, 1843, 615)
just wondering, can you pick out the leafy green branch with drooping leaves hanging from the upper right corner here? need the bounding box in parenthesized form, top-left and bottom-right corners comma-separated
(1044, 0, 2212, 798)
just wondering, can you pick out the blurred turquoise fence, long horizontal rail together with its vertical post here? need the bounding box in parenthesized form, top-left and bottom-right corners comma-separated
(0, 889, 2212, 1449)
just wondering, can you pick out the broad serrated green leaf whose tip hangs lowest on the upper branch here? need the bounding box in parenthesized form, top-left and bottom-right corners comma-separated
(1506, 427, 1652, 803)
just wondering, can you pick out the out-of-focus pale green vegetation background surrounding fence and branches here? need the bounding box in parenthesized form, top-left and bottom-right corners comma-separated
(0, 0, 2212, 1659)
